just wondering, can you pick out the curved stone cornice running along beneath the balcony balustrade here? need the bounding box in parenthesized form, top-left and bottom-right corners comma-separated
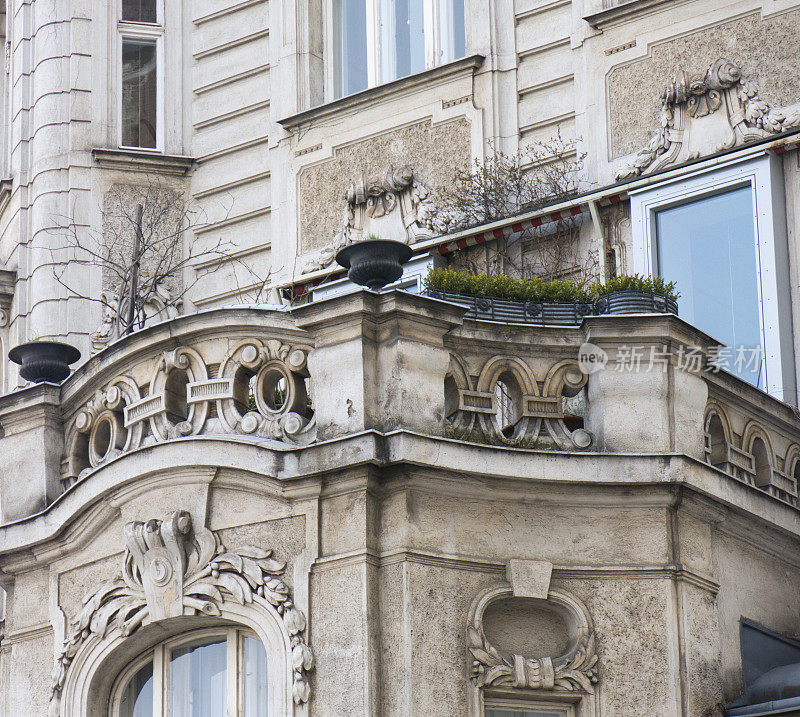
(0, 431, 800, 569)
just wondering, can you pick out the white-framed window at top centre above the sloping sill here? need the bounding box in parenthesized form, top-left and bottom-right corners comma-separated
(330, 0, 466, 97)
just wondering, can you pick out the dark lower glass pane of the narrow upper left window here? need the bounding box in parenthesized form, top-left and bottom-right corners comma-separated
(122, 40, 158, 148)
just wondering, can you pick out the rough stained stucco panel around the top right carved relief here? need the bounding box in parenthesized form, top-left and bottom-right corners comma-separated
(606, 10, 800, 158)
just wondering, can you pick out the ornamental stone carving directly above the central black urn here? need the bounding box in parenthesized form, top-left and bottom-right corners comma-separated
(303, 165, 436, 273)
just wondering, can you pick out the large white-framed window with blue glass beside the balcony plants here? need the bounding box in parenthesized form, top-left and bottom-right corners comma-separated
(630, 154, 797, 404)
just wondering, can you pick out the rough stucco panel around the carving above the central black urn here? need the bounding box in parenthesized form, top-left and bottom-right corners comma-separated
(297, 118, 470, 254)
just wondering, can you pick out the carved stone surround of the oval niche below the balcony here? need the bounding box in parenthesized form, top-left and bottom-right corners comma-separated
(467, 588, 598, 694)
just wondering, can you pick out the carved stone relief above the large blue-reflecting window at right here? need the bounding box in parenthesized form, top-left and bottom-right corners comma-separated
(617, 59, 800, 179)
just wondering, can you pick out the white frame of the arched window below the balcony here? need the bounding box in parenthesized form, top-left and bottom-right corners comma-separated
(109, 627, 268, 717)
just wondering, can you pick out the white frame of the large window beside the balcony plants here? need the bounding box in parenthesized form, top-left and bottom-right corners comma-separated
(629, 152, 797, 405)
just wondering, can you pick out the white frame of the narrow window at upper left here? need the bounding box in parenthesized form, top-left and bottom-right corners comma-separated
(115, 0, 166, 154)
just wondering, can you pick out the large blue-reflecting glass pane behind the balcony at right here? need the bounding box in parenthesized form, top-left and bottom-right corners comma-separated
(656, 186, 764, 388)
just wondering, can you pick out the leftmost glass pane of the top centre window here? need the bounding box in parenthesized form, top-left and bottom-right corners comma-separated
(333, 0, 367, 97)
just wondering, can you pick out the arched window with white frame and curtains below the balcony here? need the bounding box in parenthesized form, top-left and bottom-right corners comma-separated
(110, 628, 271, 717)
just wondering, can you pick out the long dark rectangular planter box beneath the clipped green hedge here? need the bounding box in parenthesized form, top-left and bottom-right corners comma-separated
(426, 289, 594, 326)
